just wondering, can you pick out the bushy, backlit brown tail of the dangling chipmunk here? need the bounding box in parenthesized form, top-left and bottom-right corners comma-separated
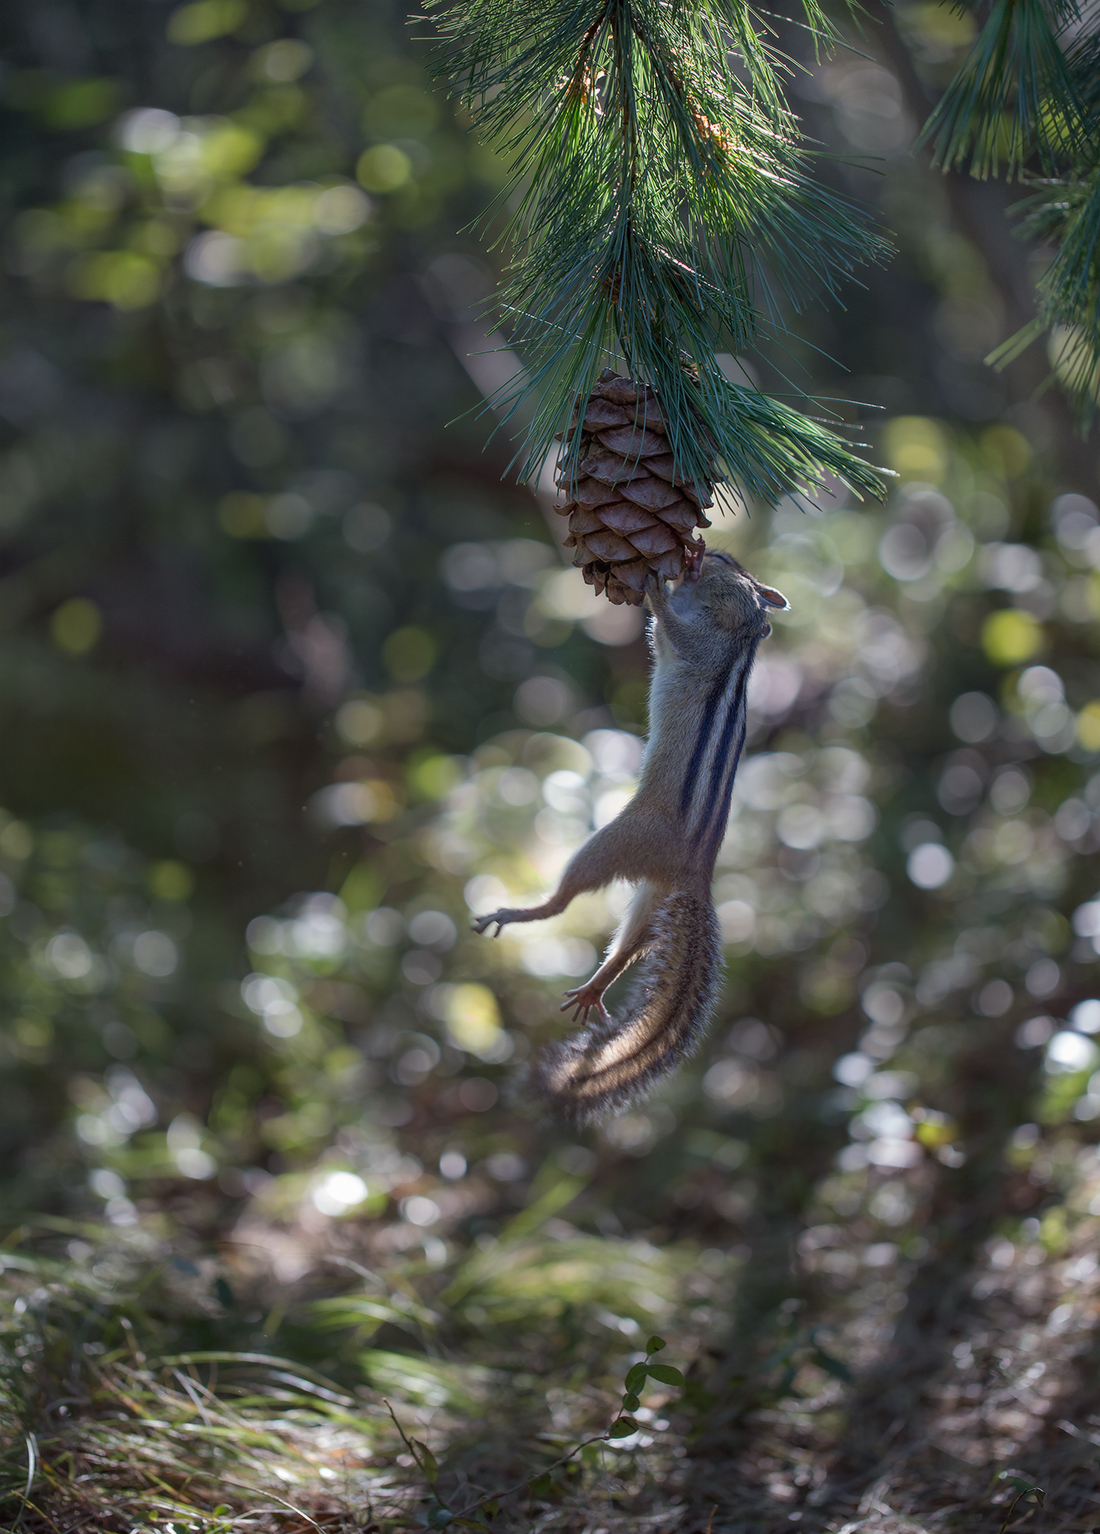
(529, 890, 721, 1123)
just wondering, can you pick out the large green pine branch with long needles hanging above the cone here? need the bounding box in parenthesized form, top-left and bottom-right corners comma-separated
(423, 0, 887, 499)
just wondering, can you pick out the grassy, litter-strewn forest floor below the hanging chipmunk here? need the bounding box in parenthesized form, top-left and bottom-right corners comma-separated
(3, 1164, 1100, 1534)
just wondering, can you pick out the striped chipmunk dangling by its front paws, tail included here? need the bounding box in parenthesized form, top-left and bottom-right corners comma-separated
(474, 554, 787, 1123)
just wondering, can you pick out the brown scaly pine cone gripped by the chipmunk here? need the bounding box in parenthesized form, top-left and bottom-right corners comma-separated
(554, 368, 713, 607)
